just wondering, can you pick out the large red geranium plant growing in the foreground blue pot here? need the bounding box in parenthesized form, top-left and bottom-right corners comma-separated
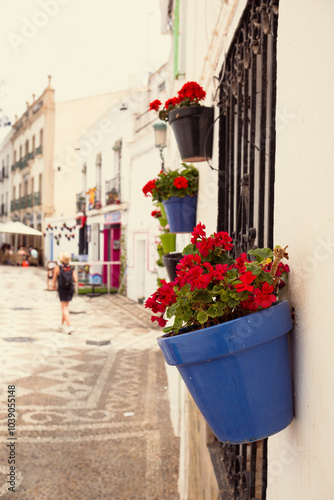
(145, 223, 289, 334)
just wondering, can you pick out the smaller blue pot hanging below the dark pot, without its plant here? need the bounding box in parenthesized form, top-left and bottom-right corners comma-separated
(163, 195, 197, 233)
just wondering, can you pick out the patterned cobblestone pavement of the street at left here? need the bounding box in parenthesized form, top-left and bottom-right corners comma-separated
(0, 266, 179, 500)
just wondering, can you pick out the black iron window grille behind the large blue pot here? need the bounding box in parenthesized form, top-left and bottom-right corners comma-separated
(214, 0, 278, 500)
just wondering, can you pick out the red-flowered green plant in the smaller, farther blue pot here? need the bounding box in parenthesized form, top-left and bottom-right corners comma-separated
(142, 163, 199, 202)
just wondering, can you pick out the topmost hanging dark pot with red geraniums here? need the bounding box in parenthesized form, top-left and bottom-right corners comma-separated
(149, 82, 214, 162)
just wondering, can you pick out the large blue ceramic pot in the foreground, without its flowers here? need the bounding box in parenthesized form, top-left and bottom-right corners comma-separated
(158, 301, 293, 444)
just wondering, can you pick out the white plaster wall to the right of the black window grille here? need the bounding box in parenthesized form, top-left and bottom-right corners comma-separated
(267, 0, 334, 500)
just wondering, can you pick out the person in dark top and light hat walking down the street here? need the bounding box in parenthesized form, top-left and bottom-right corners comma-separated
(52, 253, 77, 335)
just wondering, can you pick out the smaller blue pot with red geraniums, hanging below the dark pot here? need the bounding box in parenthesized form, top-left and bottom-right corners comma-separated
(143, 163, 199, 233)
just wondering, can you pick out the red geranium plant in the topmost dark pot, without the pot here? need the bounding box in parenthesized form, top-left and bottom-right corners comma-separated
(149, 82, 206, 122)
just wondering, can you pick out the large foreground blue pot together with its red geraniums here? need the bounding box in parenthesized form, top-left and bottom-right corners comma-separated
(145, 223, 293, 443)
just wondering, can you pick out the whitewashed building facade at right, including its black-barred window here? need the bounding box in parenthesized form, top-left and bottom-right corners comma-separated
(152, 0, 334, 500)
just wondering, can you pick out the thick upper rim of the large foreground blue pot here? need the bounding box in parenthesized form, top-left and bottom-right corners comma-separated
(158, 300, 292, 366)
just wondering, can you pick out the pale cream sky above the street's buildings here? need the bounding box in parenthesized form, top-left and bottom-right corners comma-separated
(0, 0, 171, 139)
